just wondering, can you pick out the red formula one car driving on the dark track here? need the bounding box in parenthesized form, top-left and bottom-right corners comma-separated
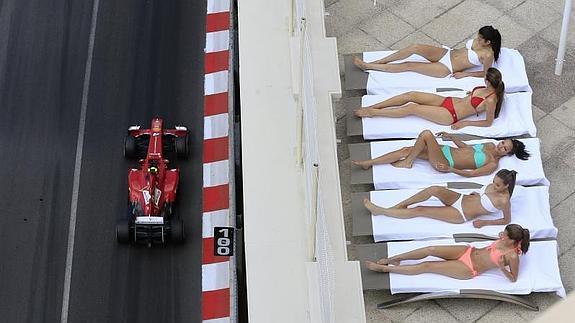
(116, 118, 189, 246)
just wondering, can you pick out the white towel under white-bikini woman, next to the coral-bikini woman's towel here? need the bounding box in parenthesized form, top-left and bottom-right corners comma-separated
(370, 185, 557, 242)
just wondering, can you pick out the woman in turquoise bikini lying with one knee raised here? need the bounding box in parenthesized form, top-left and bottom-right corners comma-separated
(352, 130, 529, 177)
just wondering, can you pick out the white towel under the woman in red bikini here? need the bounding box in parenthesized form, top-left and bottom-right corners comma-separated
(362, 91, 537, 140)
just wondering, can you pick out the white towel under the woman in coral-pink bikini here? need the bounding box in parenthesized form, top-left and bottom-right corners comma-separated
(387, 239, 565, 297)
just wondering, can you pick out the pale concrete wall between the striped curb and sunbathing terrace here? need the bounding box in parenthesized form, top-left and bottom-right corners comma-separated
(238, 0, 365, 323)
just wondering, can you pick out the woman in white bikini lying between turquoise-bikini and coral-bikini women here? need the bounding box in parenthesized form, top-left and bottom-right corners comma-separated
(363, 169, 517, 228)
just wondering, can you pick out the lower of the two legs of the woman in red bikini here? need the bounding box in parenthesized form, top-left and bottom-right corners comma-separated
(355, 103, 453, 126)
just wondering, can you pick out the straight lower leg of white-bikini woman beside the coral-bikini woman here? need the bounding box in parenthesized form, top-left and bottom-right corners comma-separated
(363, 198, 464, 224)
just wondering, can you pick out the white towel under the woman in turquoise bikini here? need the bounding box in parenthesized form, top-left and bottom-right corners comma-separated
(370, 138, 549, 190)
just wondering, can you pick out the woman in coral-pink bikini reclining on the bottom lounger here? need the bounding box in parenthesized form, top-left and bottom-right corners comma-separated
(366, 224, 529, 282)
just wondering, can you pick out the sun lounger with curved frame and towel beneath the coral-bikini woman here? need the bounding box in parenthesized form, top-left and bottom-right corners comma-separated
(356, 239, 565, 310)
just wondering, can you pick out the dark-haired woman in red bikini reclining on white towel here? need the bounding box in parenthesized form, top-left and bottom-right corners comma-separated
(355, 67, 505, 129)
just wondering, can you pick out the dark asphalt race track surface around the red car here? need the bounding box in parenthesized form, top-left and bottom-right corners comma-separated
(0, 0, 206, 322)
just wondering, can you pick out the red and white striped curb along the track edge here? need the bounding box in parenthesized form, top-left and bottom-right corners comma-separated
(202, 0, 231, 323)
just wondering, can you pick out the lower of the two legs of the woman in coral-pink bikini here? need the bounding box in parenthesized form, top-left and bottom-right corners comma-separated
(366, 260, 473, 279)
